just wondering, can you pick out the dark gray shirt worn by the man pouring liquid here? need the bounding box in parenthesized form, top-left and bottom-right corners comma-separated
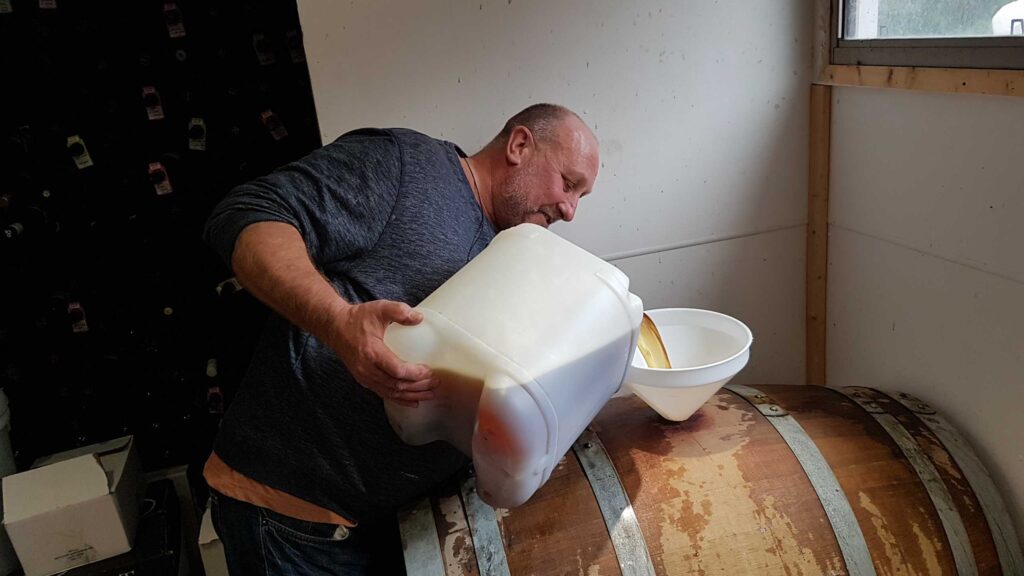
(205, 129, 495, 521)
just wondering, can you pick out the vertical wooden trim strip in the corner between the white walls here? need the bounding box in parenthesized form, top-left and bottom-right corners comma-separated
(806, 85, 831, 385)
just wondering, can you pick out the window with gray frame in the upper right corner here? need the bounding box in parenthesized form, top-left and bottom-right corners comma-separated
(833, 0, 1024, 70)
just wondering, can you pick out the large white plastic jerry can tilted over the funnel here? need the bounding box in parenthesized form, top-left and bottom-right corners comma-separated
(384, 223, 643, 507)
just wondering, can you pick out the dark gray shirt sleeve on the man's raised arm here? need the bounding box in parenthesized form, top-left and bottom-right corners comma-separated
(204, 129, 401, 266)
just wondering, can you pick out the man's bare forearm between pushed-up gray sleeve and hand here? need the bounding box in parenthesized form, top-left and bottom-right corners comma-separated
(231, 221, 349, 342)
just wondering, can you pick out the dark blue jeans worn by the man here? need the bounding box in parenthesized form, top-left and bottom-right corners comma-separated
(210, 490, 406, 576)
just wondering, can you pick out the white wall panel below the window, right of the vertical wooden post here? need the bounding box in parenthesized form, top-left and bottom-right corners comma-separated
(827, 88, 1024, 535)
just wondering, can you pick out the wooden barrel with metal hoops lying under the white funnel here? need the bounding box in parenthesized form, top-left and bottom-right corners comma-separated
(401, 385, 1024, 576)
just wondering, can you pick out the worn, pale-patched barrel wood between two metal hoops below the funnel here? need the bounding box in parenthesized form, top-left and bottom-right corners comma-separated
(592, 392, 843, 574)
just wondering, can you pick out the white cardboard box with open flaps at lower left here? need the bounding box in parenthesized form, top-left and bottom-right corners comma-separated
(3, 436, 141, 576)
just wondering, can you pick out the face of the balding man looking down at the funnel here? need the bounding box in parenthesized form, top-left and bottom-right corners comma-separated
(494, 118, 599, 230)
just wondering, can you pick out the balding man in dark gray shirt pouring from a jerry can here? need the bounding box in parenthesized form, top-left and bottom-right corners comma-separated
(204, 105, 599, 576)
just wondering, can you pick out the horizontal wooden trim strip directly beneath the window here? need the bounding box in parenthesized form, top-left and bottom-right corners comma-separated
(815, 66, 1024, 96)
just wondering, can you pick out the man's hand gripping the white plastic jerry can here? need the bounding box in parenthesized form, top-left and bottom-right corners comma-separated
(329, 300, 437, 406)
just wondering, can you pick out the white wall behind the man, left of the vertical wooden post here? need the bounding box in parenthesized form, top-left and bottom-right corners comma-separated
(299, 0, 811, 382)
